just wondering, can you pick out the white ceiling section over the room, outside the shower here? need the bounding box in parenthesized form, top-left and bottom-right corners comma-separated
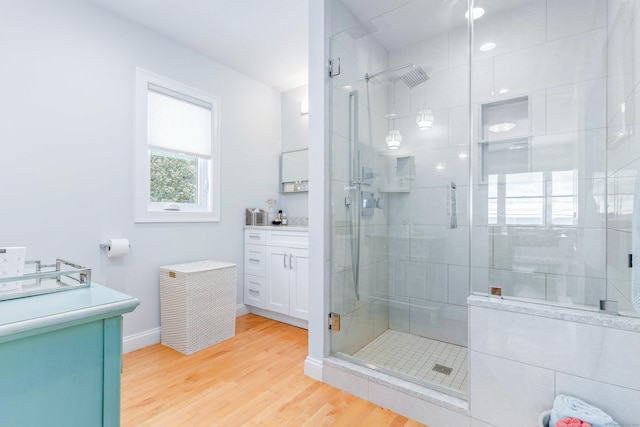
(86, 0, 309, 92)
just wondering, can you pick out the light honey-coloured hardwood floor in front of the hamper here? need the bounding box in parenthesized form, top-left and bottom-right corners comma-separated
(121, 314, 422, 427)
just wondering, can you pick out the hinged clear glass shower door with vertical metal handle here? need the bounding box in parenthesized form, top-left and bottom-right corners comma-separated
(330, 0, 470, 398)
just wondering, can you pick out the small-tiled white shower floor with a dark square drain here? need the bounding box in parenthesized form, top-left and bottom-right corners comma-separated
(353, 329, 469, 397)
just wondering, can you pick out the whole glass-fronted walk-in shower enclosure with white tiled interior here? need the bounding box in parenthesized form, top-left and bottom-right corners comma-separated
(330, 0, 637, 399)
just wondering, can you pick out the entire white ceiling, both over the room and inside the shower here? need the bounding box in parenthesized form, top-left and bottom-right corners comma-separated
(85, 0, 534, 92)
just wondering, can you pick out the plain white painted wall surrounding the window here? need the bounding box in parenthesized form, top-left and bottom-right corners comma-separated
(0, 0, 281, 346)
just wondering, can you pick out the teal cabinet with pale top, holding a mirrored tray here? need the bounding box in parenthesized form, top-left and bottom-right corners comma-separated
(0, 283, 139, 427)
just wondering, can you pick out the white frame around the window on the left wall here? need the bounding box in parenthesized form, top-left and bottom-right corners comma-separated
(134, 68, 220, 223)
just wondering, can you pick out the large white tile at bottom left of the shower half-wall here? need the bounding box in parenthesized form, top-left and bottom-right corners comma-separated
(469, 352, 554, 427)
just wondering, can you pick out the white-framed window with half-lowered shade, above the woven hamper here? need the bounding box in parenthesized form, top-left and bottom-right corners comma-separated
(135, 69, 220, 222)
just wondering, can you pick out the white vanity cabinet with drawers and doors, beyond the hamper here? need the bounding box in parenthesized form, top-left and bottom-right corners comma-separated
(244, 228, 309, 322)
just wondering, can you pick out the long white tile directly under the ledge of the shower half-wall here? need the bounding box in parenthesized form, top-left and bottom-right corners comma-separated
(469, 307, 640, 390)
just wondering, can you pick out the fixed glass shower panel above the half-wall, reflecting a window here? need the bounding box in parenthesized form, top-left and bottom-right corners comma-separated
(471, 0, 608, 306)
